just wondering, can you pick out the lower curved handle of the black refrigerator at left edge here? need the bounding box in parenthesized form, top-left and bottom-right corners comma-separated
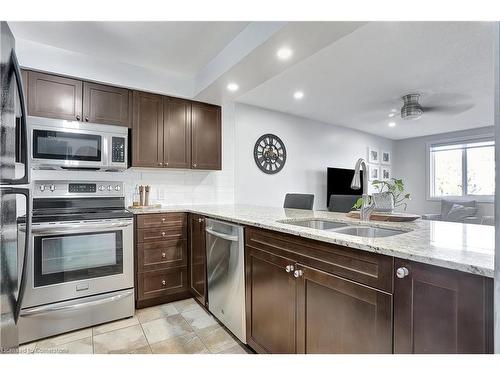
(2, 187, 31, 323)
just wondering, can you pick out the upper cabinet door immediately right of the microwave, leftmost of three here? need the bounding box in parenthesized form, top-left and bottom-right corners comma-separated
(132, 91, 163, 167)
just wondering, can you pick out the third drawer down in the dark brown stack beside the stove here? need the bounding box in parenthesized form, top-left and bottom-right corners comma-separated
(137, 239, 187, 271)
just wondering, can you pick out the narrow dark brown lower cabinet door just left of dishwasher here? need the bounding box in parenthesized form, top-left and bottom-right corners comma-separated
(189, 215, 207, 305)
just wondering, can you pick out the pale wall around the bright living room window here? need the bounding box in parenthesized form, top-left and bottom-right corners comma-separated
(393, 127, 494, 216)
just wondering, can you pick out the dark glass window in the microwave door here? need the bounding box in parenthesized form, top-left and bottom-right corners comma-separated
(33, 129, 102, 161)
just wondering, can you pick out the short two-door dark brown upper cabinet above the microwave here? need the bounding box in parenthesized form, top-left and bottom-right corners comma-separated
(23, 71, 132, 127)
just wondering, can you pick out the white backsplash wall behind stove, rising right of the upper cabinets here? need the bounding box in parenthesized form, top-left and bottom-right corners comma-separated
(31, 103, 234, 205)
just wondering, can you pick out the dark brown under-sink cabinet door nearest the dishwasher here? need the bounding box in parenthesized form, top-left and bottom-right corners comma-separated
(245, 246, 296, 354)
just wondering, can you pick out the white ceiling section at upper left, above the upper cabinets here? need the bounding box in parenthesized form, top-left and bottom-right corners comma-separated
(9, 22, 248, 75)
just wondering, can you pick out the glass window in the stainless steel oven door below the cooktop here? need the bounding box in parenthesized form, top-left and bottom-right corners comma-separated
(34, 231, 123, 287)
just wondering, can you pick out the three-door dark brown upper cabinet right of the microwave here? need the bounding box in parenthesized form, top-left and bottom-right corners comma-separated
(132, 91, 221, 170)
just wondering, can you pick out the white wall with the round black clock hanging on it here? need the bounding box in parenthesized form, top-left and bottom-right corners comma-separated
(235, 104, 393, 209)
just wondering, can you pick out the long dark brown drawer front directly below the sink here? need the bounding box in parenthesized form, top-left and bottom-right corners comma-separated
(245, 228, 394, 293)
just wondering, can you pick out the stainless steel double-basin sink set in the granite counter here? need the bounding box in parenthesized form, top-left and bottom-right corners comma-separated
(282, 219, 406, 238)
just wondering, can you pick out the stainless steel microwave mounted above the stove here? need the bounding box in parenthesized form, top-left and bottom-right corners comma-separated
(27, 116, 128, 171)
